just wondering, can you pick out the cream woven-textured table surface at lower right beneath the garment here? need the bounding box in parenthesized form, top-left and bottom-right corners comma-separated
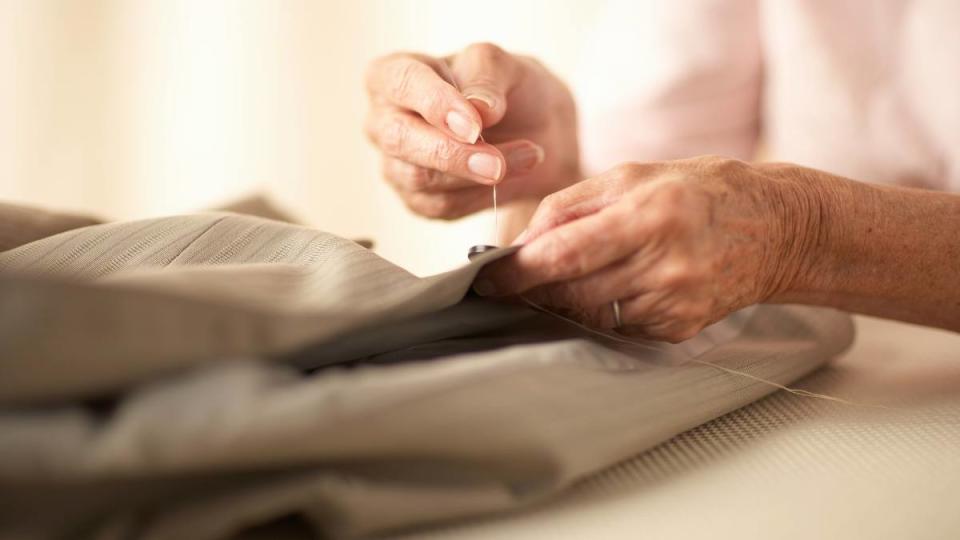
(405, 317, 960, 540)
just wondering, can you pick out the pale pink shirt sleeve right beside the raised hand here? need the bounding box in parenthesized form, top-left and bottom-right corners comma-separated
(577, 0, 761, 174)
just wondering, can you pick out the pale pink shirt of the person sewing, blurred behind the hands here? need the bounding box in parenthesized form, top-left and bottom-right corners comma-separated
(577, 0, 960, 191)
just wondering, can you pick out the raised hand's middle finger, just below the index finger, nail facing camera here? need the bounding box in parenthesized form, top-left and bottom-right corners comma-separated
(367, 107, 506, 185)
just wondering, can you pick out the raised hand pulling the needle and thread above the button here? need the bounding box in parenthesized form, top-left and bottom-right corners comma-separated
(366, 44, 580, 219)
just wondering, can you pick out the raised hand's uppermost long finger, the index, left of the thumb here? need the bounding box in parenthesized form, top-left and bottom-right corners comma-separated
(367, 54, 483, 144)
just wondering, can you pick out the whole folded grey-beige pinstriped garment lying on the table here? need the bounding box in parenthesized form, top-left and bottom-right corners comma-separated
(0, 214, 853, 538)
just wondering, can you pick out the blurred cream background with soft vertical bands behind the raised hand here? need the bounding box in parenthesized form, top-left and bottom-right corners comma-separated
(0, 0, 598, 274)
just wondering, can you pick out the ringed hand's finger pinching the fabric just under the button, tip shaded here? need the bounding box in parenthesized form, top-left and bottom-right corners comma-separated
(477, 199, 635, 296)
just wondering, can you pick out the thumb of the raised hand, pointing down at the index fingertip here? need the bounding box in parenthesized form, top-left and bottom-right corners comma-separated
(451, 43, 519, 127)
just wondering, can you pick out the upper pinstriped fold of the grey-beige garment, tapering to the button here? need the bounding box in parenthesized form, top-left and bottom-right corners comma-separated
(0, 214, 502, 402)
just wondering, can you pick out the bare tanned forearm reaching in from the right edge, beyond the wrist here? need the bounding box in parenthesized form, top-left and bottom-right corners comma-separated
(769, 170, 960, 331)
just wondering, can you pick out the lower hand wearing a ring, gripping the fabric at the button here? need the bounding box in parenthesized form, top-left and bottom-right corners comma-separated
(475, 157, 810, 342)
